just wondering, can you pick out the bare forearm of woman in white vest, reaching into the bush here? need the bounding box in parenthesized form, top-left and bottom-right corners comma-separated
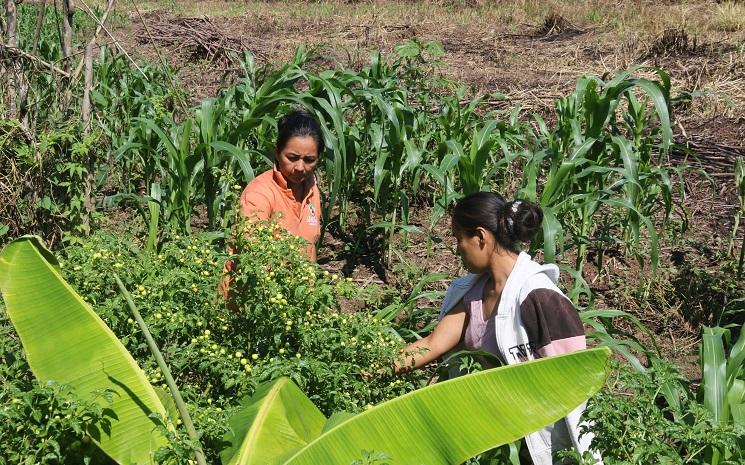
(393, 303, 466, 373)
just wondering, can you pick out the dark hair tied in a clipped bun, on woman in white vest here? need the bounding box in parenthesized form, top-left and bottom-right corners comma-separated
(452, 192, 543, 251)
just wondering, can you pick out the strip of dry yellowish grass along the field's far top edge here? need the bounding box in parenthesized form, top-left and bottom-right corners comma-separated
(125, 0, 745, 34)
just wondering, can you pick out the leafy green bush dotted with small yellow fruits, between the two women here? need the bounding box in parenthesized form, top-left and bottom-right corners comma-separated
(23, 223, 418, 463)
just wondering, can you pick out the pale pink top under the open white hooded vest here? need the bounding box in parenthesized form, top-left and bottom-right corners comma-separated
(463, 274, 501, 368)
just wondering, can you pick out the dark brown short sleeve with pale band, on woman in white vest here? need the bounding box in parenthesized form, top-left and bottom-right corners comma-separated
(520, 289, 587, 357)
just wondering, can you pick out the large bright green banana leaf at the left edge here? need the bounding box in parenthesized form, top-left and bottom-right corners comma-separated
(0, 236, 166, 465)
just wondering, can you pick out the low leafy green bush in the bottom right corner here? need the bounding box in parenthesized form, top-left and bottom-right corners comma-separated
(582, 363, 745, 465)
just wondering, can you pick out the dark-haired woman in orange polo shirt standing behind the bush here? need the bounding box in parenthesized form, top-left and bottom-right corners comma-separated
(240, 110, 324, 261)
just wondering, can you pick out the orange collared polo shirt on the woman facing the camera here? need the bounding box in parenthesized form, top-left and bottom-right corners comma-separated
(241, 168, 321, 261)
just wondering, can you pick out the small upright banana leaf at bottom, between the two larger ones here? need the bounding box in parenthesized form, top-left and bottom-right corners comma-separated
(220, 378, 326, 465)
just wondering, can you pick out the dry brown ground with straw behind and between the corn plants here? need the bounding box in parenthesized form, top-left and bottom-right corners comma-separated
(114, 0, 745, 378)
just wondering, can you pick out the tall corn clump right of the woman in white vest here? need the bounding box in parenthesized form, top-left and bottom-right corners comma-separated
(520, 69, 675, 292)
